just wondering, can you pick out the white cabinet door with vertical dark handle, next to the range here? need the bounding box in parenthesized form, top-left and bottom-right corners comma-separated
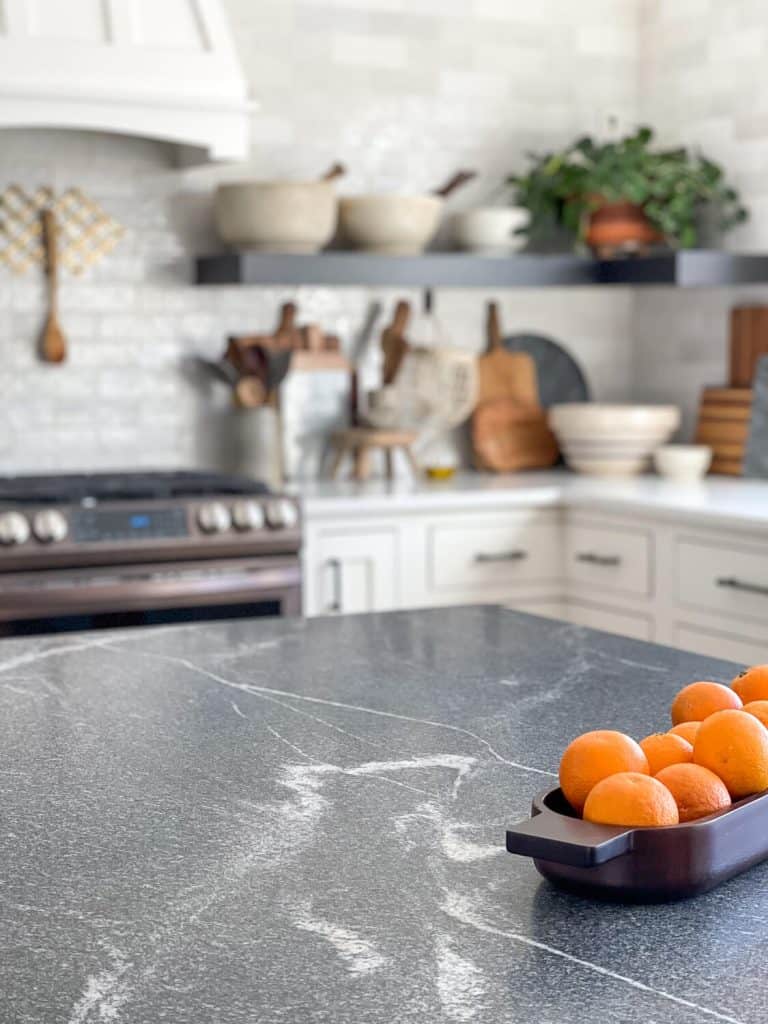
(307, 529, 398, 615)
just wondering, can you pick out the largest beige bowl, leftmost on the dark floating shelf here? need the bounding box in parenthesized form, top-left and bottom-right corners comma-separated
(214, 181, 338, 253)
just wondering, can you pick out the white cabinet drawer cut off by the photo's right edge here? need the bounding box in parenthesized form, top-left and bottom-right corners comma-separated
(677, 540, 768, 623)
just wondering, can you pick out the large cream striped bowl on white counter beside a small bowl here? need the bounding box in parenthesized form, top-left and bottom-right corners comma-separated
(549, 402, 680, 476)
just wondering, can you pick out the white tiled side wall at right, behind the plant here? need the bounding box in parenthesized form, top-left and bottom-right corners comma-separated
(633, 0, 768, 433)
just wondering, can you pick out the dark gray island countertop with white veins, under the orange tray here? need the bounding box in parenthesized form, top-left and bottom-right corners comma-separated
(0, 607, 768, 1024)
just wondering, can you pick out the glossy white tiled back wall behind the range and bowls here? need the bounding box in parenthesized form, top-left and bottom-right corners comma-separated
(0, 0, 639, 472)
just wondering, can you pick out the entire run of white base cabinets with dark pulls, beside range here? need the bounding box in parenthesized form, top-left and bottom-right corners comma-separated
(304, 484, 768, 664)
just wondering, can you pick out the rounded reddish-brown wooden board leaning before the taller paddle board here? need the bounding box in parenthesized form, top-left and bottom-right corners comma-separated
(472, 398, 559, 473)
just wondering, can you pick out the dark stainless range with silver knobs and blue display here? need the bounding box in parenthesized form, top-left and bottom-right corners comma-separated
(0, 472, 301, 636)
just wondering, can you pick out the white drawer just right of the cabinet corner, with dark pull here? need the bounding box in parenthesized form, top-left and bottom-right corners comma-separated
(565, 522, 652, 597)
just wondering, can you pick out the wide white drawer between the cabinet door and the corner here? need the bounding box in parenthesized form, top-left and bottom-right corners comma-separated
(427, 516, 560, 592)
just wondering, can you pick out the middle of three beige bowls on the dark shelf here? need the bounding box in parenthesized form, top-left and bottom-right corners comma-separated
(339, 196, 443, 256)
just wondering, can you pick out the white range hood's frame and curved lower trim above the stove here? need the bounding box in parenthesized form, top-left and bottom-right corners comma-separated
(0, 0, 252, 164)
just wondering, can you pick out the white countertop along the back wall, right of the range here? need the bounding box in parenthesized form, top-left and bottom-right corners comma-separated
(296, 470, 768, 530)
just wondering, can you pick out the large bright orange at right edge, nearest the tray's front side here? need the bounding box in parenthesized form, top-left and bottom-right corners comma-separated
(693, 711, 768, 800)
